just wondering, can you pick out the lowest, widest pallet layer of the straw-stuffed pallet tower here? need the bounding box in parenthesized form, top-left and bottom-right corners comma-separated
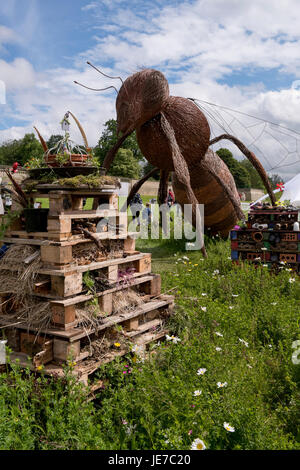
(1, 295, 174, 380)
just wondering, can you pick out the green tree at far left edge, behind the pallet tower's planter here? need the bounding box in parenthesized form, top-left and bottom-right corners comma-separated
(0, 134, 43, 165)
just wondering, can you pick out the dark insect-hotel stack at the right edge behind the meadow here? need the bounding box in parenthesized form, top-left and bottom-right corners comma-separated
(231, 206, 300, 274)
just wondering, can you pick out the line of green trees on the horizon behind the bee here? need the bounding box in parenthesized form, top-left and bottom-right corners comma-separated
(0, 119, 282, 189)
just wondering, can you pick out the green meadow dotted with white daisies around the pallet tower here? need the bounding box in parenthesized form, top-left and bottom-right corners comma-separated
(0, 227, 300, 450)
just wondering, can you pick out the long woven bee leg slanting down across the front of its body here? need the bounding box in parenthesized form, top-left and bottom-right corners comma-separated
(161, 113, 207, 258)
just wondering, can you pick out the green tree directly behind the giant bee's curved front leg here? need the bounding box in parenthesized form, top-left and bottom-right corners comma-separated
(94, 119, 144, 164)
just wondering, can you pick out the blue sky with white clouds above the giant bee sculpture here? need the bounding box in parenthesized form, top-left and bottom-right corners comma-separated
(0, 0, 300, 176)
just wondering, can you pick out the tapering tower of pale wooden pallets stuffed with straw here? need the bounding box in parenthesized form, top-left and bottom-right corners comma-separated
(0, 185, 174, 383)
